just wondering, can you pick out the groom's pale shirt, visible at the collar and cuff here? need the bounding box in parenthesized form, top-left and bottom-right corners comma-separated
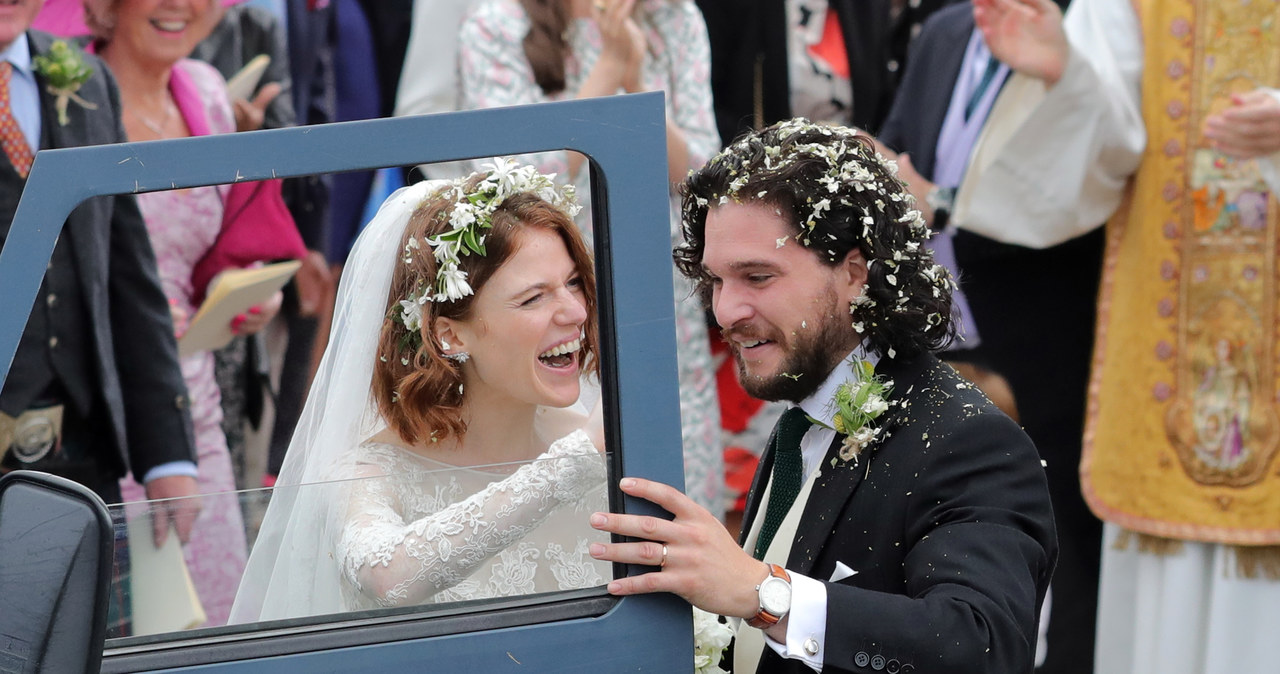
(764, 345, 879, 671)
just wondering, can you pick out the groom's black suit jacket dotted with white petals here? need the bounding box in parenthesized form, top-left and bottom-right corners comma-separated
(739, 354, 1057, 674)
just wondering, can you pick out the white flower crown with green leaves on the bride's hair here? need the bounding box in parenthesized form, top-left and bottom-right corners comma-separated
(392, 157, 582, 337)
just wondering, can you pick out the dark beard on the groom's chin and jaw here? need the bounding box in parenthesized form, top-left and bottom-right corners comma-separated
(733, 292, 856, 403)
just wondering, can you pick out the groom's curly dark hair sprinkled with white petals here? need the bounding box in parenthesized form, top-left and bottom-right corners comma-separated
(672, 119, 955, 357)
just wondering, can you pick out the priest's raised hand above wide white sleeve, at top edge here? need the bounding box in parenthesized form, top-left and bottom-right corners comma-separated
(973, 0, 1070, 87)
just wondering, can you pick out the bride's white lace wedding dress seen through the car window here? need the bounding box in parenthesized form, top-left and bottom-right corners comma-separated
(337, 431, 612, 610)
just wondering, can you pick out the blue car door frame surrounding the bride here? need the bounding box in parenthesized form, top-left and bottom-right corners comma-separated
(0, 93, 692, 674)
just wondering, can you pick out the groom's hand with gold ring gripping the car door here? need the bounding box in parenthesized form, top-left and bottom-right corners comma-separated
(591, 477, 769, 618)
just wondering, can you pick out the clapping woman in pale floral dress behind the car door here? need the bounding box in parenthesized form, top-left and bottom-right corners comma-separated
(458, 0, 724, 512)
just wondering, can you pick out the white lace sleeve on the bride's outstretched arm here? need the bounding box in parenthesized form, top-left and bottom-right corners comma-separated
(338, 431, 605, 606)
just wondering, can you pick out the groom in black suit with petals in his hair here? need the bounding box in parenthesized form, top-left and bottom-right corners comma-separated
(591, 120, 1057, 674)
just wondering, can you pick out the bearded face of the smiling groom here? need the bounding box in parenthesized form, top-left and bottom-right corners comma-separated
(703, 203, 867, 402)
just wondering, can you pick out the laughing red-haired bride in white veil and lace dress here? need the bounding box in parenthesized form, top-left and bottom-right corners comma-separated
(232, 160, 611, 623)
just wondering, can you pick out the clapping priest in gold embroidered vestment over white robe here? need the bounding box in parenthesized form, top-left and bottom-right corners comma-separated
(956, 0, 1280, 674)
